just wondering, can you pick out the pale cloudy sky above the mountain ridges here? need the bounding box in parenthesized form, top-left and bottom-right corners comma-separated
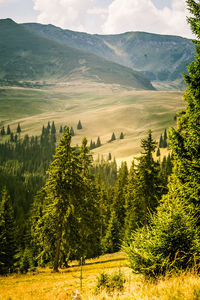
(0, 0, 192, 38)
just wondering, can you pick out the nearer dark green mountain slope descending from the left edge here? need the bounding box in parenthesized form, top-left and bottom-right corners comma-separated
(0, 19, 154, 90)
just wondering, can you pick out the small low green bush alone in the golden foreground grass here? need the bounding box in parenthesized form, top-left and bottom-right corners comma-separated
(96, 270, 126, 293)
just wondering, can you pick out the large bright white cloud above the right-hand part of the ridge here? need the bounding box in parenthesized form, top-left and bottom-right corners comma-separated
(102, 0, 191, 36)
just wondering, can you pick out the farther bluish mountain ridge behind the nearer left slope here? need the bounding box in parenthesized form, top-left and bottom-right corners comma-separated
(24, 23, 194, 89)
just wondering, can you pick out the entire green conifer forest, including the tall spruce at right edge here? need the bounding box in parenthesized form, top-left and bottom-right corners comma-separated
(0, 0, 200, 277)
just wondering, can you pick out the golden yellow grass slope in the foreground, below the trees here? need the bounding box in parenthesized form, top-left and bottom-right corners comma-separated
(0, 253, 200, 300)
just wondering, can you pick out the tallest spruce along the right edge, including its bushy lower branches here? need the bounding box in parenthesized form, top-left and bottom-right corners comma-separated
(126, 0, 200, 276)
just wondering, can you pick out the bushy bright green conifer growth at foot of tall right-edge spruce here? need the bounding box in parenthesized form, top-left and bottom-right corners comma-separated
(124, 198, 200, 277)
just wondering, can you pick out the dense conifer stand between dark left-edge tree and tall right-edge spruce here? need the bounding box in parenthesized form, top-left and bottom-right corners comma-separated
(0, 122, 171, 273)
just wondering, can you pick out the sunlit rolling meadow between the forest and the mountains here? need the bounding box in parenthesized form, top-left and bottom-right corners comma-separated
(0, 81, 184, 161)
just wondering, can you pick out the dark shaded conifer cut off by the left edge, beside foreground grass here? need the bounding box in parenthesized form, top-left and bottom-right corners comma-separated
(0, 188, 17, 274)
